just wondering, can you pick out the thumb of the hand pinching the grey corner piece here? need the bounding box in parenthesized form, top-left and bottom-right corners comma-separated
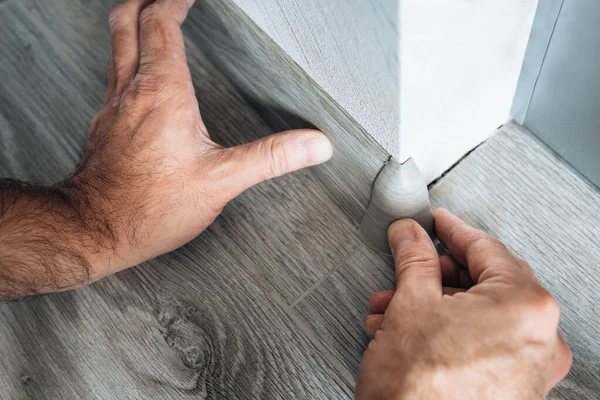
(388, 219, 442, 299)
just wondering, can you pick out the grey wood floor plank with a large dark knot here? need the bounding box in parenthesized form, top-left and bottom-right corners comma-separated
(0, 227, 351, 399)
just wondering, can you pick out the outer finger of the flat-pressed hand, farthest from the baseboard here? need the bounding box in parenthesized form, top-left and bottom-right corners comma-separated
(108, 0, 152, 95)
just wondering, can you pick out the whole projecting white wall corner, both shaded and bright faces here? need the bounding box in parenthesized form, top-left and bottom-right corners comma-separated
(235, 0, 536, 181)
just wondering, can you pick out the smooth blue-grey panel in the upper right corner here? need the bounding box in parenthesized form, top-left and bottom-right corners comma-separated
(513, 0, 600, 186)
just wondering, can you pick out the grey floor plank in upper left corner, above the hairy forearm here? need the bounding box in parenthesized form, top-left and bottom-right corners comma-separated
(0, 2, 101, 184)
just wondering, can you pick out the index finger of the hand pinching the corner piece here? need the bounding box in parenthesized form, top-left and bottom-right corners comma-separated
(434, 209, 521, 283)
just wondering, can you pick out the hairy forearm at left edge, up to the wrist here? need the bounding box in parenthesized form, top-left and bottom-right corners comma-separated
(0, 179, 114, 298)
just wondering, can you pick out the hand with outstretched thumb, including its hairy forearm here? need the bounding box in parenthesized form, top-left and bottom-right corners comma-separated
(0, 0, 332, 297)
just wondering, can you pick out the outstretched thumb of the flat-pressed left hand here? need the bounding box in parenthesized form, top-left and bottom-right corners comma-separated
(217, 129, 333, 198)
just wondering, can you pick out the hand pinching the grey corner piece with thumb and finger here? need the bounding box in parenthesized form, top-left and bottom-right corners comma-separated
(356, 209, 571, 400)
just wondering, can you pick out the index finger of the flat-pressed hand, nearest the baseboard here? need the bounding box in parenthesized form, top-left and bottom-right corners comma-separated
(139, 0, 194, 78)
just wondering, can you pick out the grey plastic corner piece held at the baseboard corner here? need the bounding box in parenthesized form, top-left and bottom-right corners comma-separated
(360, 157, 434, 255)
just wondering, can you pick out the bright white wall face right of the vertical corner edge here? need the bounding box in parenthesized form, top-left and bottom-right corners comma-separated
(400, 0, 536, 181)
